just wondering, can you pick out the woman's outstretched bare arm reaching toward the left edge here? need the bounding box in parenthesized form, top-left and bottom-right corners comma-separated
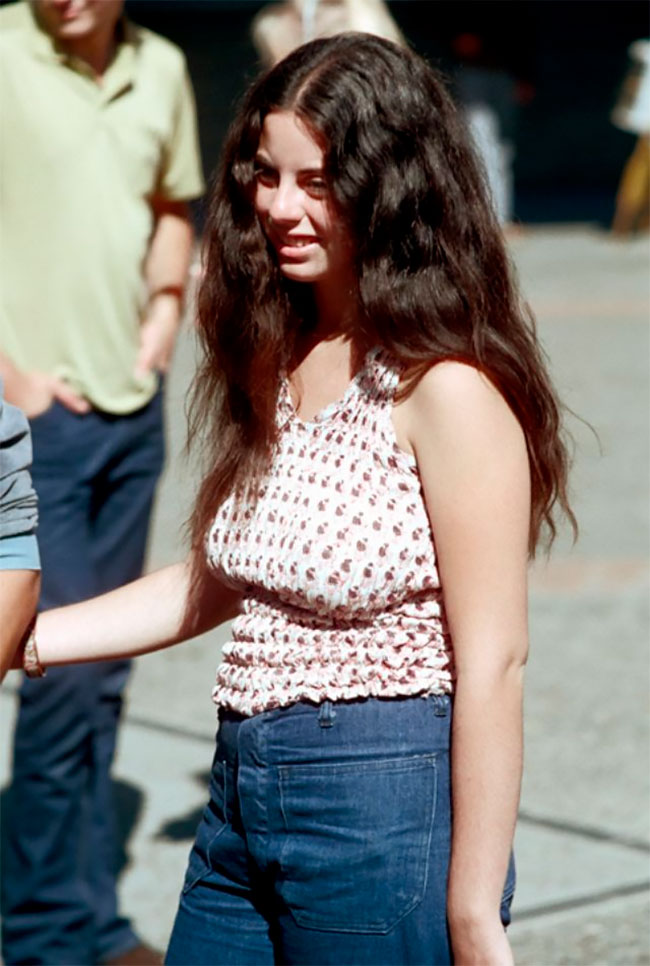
(24, 561, 240, 667)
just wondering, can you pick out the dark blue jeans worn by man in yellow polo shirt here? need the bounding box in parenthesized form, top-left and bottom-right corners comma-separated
(2, 394, 163, 966)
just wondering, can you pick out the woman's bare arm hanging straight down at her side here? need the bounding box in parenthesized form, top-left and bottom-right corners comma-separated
(408, 362, 530, 966)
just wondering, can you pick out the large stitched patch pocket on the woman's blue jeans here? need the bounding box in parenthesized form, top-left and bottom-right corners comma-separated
(278, 754, 436, 933)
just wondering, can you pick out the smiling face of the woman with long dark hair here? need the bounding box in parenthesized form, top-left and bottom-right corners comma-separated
(255, 111, 351, 284)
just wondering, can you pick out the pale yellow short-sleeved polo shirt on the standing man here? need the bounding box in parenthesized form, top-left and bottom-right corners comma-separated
(0, 2, 203, 414)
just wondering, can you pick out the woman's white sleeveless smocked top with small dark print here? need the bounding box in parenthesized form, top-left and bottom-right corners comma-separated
(207, 349, 453, 715)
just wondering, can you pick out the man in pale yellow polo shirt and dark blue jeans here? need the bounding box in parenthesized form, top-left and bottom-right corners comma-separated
(0, 0, 203, 964)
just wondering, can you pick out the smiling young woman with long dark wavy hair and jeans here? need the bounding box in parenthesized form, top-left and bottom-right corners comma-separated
(13, 34, 572, 966)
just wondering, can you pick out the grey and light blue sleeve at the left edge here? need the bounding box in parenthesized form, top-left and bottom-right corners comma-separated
(0, 384, 40, 570)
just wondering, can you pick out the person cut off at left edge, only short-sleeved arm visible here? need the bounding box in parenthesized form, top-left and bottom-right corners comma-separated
(0, 379, 41, 680)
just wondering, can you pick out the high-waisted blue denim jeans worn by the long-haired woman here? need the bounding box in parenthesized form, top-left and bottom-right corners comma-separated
(166, 696, 514, 966)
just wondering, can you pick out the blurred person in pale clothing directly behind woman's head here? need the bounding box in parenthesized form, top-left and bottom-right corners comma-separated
(252, 0, 404, 67)
